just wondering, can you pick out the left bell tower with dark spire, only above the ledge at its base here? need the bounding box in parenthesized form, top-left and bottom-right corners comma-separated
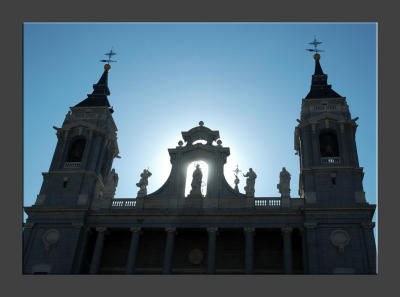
(36, 63, 118, 207)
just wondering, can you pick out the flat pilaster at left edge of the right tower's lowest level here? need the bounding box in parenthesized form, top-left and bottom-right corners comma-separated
(304, 223, 319, 274)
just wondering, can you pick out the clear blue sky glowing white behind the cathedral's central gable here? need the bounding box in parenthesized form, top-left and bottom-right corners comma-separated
(24, 23, 377, 224)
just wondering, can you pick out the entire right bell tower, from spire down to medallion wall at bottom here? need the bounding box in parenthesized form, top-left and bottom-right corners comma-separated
(295, 53, 376, 274)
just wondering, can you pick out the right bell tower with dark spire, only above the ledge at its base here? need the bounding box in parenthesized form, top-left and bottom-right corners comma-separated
(295, 54, 365, 205)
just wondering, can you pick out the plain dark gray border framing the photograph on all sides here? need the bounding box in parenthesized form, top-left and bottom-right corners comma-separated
(0, 0, 399, 296)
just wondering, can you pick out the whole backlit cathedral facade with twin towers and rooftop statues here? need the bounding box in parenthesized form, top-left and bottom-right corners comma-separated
(23, 53, 376, 274)
